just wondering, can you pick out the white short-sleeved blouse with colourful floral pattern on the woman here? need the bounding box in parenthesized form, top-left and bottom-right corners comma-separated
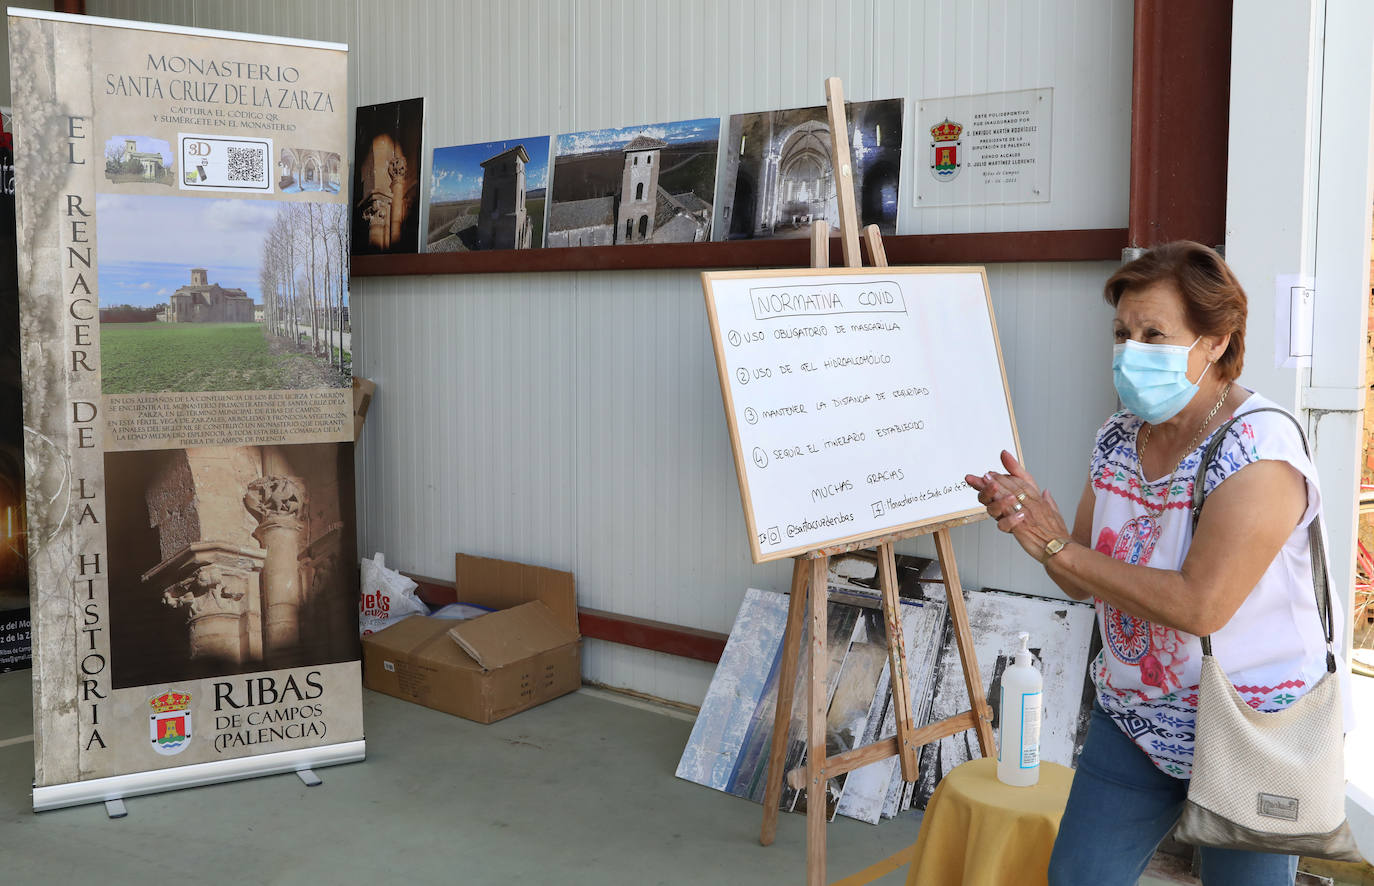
(1090, 394, 1341, 779)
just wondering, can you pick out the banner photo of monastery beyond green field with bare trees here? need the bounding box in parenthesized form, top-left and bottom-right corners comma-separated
(96, 194, 352, 394)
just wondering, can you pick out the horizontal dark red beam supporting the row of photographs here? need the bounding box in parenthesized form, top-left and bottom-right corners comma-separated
(352, 228, 1127, 277)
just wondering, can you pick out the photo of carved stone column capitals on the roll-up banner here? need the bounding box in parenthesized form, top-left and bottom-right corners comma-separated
(104, 444, 359, 688)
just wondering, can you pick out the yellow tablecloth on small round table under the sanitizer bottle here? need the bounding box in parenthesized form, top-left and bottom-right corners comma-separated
(907, 757, 1073, 886)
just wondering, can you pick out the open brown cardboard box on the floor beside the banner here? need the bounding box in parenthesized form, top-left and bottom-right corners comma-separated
(363, 554, 583, 723)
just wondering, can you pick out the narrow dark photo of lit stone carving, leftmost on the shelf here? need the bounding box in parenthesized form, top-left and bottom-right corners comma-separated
(353, 99, 425, 255)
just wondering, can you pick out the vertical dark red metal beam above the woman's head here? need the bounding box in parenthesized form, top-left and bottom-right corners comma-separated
(1128, 0, 1231, 249)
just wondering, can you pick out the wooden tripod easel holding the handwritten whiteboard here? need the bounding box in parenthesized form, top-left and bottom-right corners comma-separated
(758, 77, 995, 886)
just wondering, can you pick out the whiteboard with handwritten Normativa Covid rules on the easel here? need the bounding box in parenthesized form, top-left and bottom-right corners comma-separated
(701, 268, 1021, 563)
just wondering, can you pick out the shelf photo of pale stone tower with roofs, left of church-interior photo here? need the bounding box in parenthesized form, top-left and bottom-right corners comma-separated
(545, 117, 720, 246)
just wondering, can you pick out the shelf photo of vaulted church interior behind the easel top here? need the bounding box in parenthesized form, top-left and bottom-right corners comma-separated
(717, 99, 901, 240)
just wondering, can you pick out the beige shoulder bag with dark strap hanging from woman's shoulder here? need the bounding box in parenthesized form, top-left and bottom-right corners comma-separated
(1173, 407, 1363, 861)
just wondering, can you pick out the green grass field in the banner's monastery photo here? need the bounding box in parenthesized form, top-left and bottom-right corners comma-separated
(100, 323, 346, 394)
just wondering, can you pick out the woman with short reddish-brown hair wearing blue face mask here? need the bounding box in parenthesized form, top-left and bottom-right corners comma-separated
(967, 242, 1326, 886)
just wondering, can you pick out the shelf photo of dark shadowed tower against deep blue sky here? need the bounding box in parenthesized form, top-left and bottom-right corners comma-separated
(425, 136, 550, 253)
